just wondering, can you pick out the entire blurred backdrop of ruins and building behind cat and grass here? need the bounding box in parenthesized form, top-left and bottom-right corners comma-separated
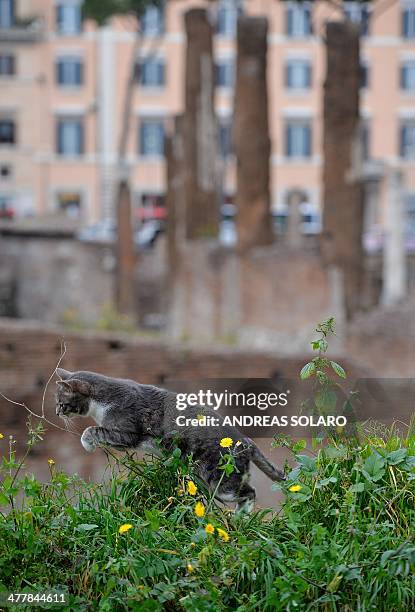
(0, 0, 415, 506)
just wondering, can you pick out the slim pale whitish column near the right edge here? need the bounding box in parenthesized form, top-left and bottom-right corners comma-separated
(382, 168, 407, 306)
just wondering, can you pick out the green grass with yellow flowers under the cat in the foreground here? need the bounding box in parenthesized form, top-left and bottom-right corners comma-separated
(0, 430, 415, 612)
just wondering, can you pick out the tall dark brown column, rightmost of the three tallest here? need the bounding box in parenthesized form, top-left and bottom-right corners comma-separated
(322, 21, 363, 318)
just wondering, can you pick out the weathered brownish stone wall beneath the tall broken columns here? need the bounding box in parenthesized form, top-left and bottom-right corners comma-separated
(169, 242, 343, 354)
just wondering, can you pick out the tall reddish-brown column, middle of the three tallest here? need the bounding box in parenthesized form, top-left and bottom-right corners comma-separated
(234, 16, 273, 250)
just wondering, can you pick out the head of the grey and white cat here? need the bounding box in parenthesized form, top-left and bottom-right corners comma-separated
(56, 368, 91, 418)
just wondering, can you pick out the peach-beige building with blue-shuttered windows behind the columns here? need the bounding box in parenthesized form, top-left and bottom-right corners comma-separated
(0, 0, 415, 232)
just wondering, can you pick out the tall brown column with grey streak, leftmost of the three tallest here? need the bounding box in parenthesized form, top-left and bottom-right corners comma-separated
(184, 8, 219, 239)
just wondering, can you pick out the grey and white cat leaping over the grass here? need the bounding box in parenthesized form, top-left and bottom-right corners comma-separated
(56, 368, 285, 512)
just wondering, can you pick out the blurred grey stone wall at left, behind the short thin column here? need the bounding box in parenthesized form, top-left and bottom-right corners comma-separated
(0, 227, 166, 326)
